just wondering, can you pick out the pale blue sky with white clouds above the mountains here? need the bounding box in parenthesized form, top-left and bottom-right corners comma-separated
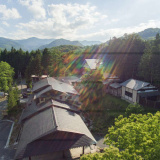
(0, 0, 160, 42)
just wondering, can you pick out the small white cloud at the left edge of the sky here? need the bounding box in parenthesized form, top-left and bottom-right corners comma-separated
(0, 5, 21, 20)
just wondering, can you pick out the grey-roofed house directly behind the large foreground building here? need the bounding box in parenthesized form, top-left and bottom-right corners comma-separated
(32, 77, 79, 105)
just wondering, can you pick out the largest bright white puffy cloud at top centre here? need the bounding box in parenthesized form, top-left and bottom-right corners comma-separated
(48, 3, 107, 29)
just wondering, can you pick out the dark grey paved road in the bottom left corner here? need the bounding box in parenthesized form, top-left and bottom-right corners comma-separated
(0, 120, 15, 160)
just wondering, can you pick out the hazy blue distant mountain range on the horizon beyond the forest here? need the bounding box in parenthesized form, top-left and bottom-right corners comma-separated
(0, 28, 160, 51)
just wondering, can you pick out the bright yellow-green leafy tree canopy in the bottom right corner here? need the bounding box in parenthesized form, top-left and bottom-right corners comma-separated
(81, 112, 160, 160)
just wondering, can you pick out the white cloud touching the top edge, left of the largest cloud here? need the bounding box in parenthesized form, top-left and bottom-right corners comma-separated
(19, 0, 46, 19)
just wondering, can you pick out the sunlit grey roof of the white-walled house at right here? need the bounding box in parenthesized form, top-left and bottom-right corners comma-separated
(121, 79, 150, 90)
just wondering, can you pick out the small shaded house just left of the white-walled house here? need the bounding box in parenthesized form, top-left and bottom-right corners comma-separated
(107, 83, 122, 97)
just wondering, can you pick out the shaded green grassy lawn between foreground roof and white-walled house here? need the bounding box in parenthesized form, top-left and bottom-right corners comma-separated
(82, 94, 129, 135)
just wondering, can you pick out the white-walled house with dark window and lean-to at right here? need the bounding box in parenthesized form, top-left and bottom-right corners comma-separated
(121, 79, 160, 103)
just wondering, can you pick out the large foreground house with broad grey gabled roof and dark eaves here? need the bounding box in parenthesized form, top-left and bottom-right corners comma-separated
(15, 100, 96, 160)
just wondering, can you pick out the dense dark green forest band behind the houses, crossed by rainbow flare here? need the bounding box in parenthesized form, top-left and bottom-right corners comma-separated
(0, 34, 160, 86)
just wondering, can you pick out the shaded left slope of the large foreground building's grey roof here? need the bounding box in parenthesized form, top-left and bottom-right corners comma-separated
(16, 108, 56, 159)
